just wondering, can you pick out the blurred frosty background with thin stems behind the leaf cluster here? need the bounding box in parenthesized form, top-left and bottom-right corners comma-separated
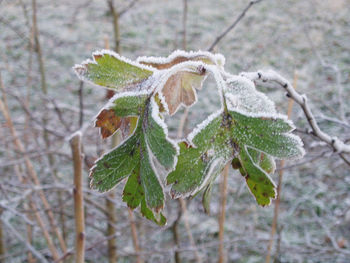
(0, 0, 350, 263)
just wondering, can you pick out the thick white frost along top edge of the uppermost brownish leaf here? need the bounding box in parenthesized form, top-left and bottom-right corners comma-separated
(136, 50, 225, 67)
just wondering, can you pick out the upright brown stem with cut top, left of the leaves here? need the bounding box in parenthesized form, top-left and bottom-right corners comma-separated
(70, 132, 85, 263)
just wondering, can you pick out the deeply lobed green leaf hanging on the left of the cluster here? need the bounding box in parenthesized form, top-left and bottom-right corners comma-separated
(91, 96, 178, 224)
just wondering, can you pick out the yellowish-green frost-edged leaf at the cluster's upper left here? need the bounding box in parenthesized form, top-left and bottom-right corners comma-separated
(74, 50, 154, 91)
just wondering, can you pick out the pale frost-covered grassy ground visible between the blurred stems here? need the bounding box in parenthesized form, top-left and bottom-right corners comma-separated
(0, 0, 350, 263)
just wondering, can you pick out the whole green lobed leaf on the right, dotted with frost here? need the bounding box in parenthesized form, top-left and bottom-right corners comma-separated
(167, 110, 303, 207)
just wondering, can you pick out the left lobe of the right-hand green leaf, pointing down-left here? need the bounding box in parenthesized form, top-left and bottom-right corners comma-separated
(167, 112, 236, 198)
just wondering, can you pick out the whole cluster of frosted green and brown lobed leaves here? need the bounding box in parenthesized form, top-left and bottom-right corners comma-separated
(74, 50, 303, 225)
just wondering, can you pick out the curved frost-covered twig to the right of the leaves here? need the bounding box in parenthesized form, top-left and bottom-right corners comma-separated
(241, 71, 350, 158)
